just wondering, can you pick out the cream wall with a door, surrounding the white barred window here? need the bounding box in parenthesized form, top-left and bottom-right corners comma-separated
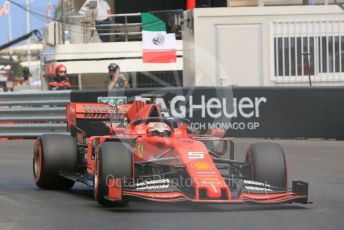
(183, 5, 344, 86)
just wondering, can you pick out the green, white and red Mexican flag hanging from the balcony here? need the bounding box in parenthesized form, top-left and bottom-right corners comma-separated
(141, 13, 176, 63)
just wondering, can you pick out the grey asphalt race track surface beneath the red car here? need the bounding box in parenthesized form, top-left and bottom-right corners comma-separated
(0, 139, 344, 230)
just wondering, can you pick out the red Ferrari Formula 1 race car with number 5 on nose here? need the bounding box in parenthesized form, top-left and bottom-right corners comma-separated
(33, 94, 308, 206)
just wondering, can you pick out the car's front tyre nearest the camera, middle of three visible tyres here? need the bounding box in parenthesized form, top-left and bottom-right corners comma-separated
(94, 142, 133, 207)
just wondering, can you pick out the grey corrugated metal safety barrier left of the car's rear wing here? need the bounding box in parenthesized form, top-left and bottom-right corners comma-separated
(0, 91, 70, 138)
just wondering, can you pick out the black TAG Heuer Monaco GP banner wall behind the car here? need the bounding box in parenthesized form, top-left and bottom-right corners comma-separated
(71, 87, 344, 139)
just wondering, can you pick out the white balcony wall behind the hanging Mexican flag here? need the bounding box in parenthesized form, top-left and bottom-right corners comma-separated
(53, 41, 183, 74)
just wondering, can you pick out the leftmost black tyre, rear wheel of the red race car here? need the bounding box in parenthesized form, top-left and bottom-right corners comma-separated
(33, 134, 78, 190)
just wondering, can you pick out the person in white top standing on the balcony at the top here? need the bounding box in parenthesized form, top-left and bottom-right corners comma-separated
(79, 0, 112, 42)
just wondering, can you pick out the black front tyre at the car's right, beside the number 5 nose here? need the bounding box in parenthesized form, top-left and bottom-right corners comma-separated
(246, 142, 288, 191)
